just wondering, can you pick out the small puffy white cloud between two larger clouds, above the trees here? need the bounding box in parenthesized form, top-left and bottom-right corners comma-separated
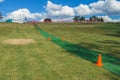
(74, 4, 93, 16)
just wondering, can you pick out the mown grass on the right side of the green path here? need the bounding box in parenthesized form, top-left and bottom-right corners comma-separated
(39, 23, 120, 58)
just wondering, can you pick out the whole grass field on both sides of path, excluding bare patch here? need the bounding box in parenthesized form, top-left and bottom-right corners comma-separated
(0, 23, 120, 80)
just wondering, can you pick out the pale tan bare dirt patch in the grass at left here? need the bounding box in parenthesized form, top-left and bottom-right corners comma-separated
(3, 39, 35, 45)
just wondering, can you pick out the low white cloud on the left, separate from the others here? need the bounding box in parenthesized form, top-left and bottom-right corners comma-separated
(4, 8, 42, 22)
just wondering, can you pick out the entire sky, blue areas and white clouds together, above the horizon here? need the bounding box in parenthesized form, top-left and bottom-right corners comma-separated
(0, 0, 120, 21)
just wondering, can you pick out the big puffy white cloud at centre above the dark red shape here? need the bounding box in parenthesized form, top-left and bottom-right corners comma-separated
(44, 1, 75, 18)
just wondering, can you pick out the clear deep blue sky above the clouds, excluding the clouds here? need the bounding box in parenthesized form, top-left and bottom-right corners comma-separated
(0, 0, 98, 14)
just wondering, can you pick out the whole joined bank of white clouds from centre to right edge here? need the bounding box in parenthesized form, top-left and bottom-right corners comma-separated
(44, 0, 120, 18)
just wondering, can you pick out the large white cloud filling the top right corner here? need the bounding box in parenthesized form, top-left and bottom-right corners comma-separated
(89, 0, 120, 15)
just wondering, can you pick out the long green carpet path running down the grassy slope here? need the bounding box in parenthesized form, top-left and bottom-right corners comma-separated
(34, 24, 120, 75)
